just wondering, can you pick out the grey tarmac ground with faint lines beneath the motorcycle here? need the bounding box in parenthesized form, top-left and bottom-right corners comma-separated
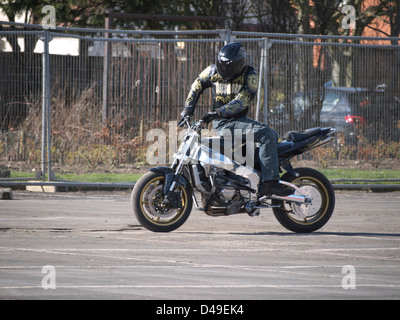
(0, 191, 400, 300)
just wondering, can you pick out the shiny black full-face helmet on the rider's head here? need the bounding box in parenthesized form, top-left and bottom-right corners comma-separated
(217, 42, 246, 81)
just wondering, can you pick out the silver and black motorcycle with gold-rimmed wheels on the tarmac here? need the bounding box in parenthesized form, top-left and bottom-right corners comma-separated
(131, 117, 336, 233)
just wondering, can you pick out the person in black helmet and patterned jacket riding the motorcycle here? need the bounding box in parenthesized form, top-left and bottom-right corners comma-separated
(181, 42, 292, 197)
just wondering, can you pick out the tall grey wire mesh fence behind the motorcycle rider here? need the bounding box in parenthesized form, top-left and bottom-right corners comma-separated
(0, 22, 400, 187)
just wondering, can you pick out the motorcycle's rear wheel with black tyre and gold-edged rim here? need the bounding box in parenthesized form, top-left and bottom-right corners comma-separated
(272, 168, 335, 233)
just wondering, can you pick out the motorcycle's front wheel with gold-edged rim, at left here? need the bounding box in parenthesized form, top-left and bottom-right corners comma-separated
(131, 171, 193, 232)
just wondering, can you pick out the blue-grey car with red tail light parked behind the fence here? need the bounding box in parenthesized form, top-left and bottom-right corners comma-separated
(320, 87, 370, 143)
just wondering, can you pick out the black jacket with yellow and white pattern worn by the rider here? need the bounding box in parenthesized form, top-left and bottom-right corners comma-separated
(185, 64, 258, 118)
